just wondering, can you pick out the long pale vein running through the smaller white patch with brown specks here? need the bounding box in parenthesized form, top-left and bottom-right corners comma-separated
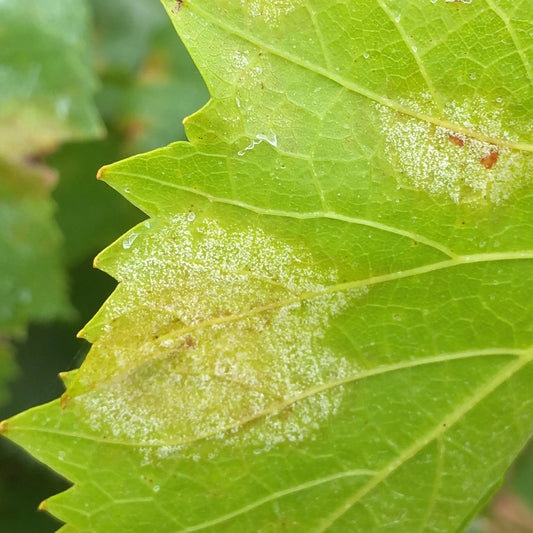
(180, 2, 533, 152)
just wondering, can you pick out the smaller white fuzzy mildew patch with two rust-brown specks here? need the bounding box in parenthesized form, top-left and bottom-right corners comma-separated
(376, 94, 533, 205)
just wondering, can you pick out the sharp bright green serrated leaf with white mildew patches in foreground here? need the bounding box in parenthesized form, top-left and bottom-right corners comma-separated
(2, 0, 533, 533)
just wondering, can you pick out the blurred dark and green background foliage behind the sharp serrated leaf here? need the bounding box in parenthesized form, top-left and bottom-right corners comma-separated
(0, 0, 533, 533)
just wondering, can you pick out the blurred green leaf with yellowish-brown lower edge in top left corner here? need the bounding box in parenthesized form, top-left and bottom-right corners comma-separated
(0, 0, 102, 160)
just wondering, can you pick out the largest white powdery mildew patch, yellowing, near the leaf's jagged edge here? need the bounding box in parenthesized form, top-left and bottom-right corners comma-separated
(75, 214, 365, 460)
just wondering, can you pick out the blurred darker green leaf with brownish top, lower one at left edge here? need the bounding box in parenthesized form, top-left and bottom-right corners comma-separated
(0, 159, 71, 336)
